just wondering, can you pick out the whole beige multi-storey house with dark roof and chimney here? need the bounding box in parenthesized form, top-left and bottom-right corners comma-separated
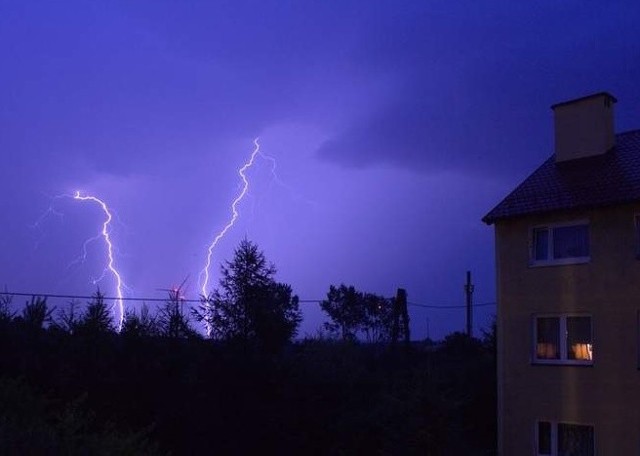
(483, 93, 640, 456)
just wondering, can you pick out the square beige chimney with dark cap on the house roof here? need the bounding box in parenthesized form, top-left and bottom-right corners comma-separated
(551, 92, 618, 162)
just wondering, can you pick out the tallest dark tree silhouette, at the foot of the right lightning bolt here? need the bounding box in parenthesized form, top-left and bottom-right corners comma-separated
(195, 239, 302, 350)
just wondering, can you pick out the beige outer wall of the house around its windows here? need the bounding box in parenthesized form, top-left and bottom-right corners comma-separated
(496, 204, 640, 456)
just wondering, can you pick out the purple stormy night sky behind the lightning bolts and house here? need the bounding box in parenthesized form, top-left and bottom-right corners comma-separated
(0, 0, 640, 339)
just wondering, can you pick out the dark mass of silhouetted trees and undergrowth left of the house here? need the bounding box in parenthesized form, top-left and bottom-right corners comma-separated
(0, 241, 495, 456)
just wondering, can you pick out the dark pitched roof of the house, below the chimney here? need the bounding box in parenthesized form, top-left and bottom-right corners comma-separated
(482, 130, 640, 225)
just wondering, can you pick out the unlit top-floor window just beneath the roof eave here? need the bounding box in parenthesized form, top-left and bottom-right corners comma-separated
(531, 222, 590, 265)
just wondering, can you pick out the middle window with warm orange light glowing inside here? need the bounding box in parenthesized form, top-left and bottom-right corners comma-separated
(533, 315, 593, 364)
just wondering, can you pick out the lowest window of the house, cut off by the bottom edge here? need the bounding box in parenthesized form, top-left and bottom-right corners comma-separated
(536, 421, 595, 456)
